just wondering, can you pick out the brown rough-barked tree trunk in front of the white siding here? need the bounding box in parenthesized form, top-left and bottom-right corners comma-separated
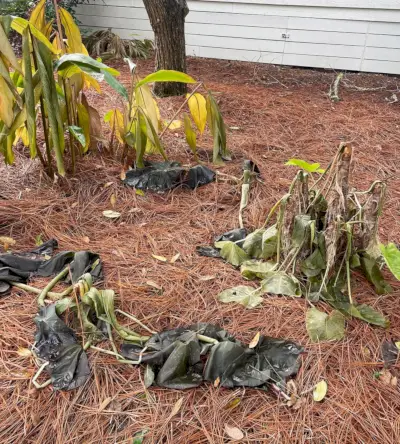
(143, 0, 189, 97)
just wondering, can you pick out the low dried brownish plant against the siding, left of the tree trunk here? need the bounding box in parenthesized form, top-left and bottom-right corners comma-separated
(83, 28, 153, 60)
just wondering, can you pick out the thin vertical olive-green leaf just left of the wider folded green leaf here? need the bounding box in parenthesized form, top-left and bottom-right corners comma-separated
(22, 29, 37, 158)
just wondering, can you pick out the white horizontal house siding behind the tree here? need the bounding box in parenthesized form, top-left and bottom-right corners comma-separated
(78, 0, 400, 74)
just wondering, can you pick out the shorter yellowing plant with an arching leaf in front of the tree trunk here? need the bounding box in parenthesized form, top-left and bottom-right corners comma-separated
(104, 59, 230, 168)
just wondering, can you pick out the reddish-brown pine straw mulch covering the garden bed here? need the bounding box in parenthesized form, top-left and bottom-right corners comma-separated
(0, 59, 400, 444)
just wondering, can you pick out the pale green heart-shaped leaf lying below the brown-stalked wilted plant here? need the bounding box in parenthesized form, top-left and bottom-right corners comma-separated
(306, 307, 345, 342)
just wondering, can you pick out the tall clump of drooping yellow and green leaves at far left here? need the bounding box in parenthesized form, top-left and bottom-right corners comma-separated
(0, 0, 128, 176)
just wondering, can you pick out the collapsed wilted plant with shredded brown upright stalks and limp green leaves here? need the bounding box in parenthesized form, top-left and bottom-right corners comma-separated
(215, 144, 400, 332)
